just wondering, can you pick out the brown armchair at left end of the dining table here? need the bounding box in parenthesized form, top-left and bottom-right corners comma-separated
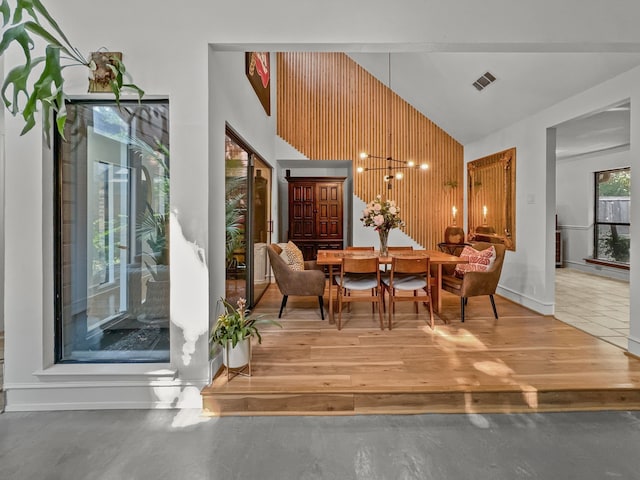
(267, 243, 326, 320)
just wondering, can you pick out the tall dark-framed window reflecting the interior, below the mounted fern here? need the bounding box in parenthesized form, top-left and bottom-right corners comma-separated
(55, 101, 169, 362)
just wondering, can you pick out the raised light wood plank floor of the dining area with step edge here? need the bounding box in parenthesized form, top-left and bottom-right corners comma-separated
(202, 286, 640, 415)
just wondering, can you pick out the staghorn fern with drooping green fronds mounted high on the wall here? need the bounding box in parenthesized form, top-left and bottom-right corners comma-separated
(0, 0, 144, 144)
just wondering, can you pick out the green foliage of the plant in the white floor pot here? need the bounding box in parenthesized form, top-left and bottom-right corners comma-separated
(209, 298, 282, 355)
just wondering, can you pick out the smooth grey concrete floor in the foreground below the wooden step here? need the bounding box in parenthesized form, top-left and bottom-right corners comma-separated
(0, 410, 640, 480)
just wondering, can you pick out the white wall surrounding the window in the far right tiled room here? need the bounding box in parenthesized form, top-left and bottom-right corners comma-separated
(556, 147, 632, 281)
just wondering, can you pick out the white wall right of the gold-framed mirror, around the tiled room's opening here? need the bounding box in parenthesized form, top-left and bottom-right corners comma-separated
(465, 63, 640, 354)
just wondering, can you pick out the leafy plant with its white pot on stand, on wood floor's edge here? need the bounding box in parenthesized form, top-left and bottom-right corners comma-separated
(209, 298, 282, 369)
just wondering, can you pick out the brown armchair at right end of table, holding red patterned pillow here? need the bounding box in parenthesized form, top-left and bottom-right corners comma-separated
(442, 242, 506, 322)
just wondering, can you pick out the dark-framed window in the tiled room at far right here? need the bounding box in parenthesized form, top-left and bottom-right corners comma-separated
(593, 168, 631, 264)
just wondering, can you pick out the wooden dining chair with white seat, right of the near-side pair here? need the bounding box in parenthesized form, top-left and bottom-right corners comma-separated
(382, 256, 434, 330)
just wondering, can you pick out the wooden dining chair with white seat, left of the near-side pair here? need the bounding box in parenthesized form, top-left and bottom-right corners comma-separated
(336, 256, 384, 330)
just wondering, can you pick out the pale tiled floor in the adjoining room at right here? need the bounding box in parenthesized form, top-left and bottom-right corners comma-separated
(555, 268, 629, 350)
